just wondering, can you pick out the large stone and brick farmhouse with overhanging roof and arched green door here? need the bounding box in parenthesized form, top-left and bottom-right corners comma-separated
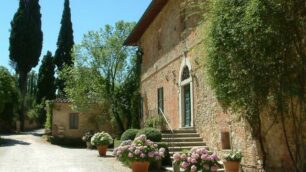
(125, 0, 306, 172)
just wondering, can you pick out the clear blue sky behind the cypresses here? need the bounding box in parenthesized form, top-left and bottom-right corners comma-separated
(0, 0, 151, 72)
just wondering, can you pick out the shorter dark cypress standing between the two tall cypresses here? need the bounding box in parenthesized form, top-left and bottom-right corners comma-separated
(36, 51, 56, 104)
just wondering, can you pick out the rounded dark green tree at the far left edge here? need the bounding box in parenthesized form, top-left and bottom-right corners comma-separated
(0, 67, 19, 130)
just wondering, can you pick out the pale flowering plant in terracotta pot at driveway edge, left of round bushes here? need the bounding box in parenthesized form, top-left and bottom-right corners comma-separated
(91, 131, 113, 156)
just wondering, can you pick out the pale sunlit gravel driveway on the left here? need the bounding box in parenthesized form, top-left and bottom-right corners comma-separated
(0, 130, 131, 172)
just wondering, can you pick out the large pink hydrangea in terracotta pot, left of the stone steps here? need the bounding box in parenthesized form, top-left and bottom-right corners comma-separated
(113, 135, 165, 172)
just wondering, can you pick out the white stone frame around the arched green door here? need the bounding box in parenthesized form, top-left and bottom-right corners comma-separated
(179, 58, 194, 128)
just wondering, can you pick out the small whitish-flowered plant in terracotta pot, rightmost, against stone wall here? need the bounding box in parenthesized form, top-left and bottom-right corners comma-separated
(223, 150, 243, 172)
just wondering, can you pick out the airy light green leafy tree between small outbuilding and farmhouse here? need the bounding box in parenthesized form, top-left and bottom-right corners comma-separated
(64, 21, 136, 133)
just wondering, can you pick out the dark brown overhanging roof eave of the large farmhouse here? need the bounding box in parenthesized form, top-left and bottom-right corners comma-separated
(123, 0, 169, 46)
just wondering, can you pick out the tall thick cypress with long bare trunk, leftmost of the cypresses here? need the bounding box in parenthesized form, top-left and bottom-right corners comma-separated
(9, 0, 43, 130)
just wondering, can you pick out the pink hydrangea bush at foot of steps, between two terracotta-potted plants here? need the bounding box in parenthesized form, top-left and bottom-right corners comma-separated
(173, 148, 220, 172)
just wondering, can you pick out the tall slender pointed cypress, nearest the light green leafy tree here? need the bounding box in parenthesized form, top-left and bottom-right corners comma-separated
(55, 0, 74, 94)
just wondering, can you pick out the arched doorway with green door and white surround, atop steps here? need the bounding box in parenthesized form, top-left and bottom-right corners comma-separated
(179, 59, 193, 128)
